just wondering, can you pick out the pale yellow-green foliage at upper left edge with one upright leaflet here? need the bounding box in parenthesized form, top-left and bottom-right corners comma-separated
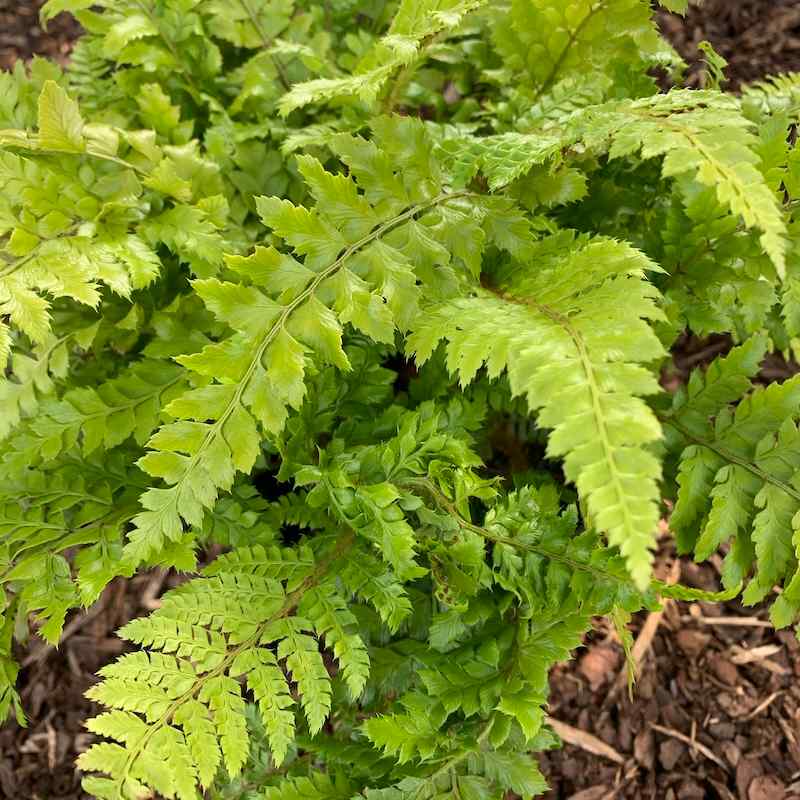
(0, 80, 234, 358)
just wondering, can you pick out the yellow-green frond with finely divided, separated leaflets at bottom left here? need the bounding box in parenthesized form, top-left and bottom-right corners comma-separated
(80, 544, 368, 800)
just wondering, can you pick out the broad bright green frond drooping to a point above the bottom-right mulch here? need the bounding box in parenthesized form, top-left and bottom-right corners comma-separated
(408, 233, 662, 588)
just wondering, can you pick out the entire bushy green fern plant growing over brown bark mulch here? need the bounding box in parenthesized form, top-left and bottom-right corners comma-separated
(0, 0, 800, 800)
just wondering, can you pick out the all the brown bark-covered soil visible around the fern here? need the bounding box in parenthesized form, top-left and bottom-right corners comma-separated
(0, 0, 800, 800)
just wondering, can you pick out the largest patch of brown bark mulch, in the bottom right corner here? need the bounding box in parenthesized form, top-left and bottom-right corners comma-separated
(542, 562, 800, 800)
